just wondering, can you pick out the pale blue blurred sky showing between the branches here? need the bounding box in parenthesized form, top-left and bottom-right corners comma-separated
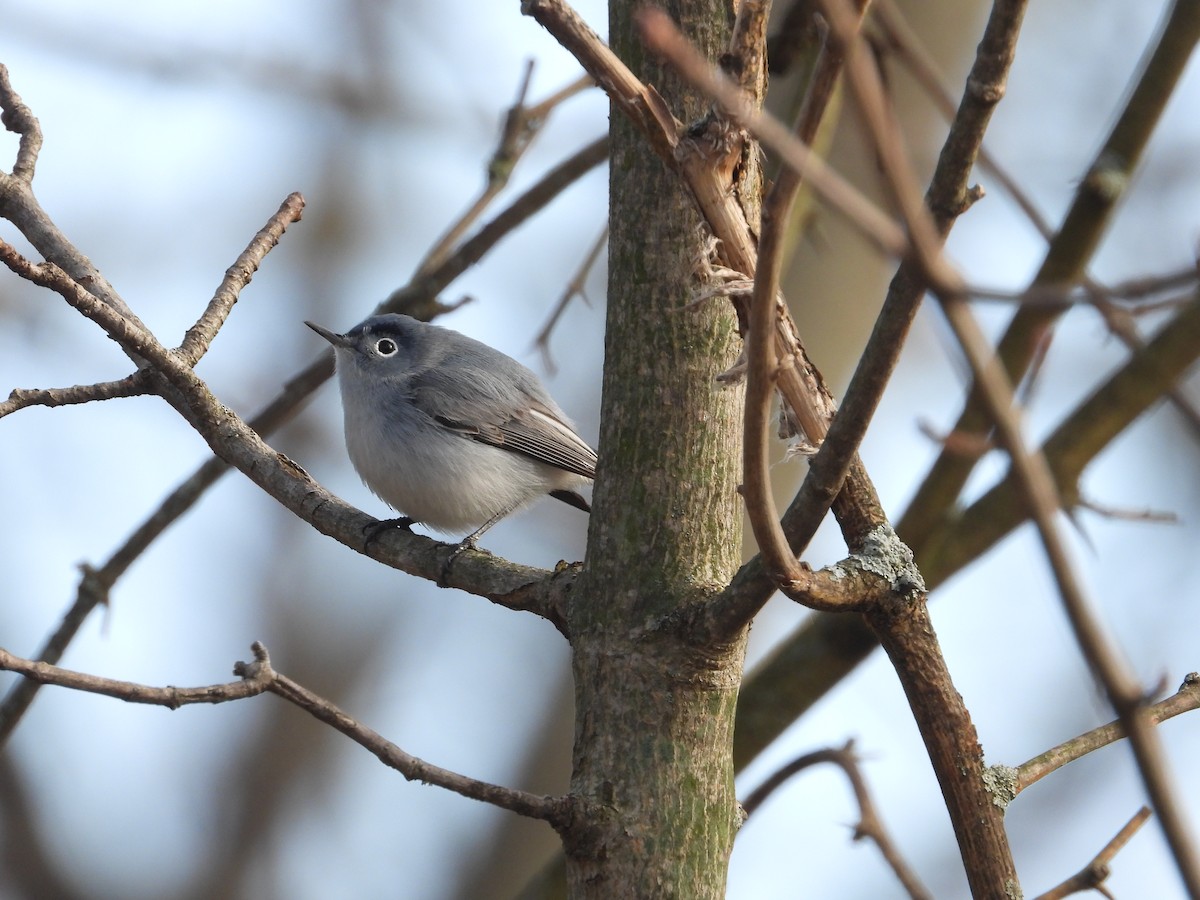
(0, 0, 1200, 900)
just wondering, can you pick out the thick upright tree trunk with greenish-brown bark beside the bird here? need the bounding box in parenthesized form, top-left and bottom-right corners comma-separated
(566, 0, 745, 898)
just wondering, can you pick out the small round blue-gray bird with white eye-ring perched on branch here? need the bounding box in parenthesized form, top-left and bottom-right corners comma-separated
(305, 314, 596, 546)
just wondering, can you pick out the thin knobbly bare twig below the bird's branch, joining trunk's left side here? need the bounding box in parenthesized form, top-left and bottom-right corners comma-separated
(0, 642, 571, 827)
